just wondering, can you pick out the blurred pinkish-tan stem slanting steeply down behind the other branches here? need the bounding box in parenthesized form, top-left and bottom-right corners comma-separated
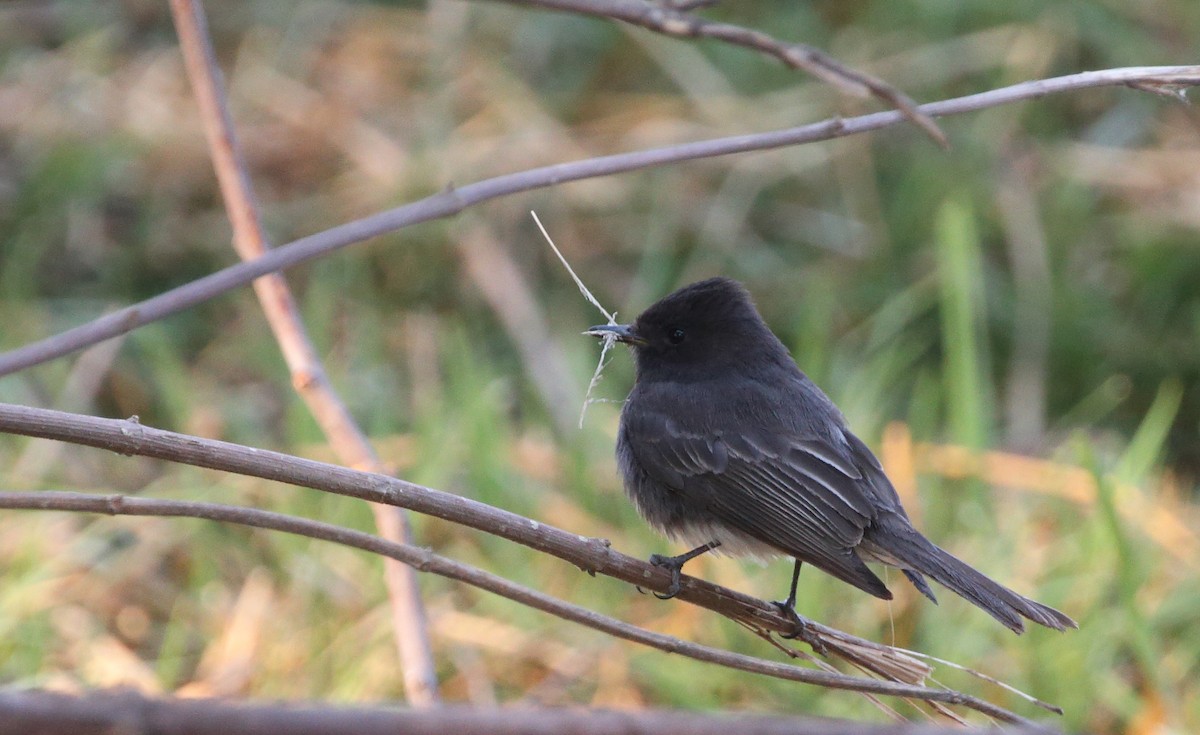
(170, 0, 438, 706)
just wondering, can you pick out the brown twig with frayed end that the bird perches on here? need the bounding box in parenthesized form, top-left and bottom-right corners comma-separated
(0, 404, 1051, 720)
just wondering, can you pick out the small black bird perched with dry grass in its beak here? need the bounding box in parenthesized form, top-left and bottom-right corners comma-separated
(586, 279, 1078, 633)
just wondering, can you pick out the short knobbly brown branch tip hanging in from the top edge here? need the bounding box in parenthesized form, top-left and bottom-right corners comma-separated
(487, 0, 949, 148)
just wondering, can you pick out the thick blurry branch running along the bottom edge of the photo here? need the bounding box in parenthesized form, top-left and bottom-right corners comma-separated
(0, 691, 1049, 735)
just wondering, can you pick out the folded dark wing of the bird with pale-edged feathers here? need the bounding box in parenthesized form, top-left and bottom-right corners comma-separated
(625, 405, 887, 594)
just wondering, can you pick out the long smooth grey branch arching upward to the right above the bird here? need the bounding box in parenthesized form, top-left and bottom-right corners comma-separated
(0, 66, 1200, 377)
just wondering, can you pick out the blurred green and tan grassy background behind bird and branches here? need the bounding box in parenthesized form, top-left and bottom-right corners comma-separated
(0, 0, 1200, 733)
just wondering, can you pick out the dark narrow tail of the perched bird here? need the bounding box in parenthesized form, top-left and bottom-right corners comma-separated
(864, 526, 1079, 633)
